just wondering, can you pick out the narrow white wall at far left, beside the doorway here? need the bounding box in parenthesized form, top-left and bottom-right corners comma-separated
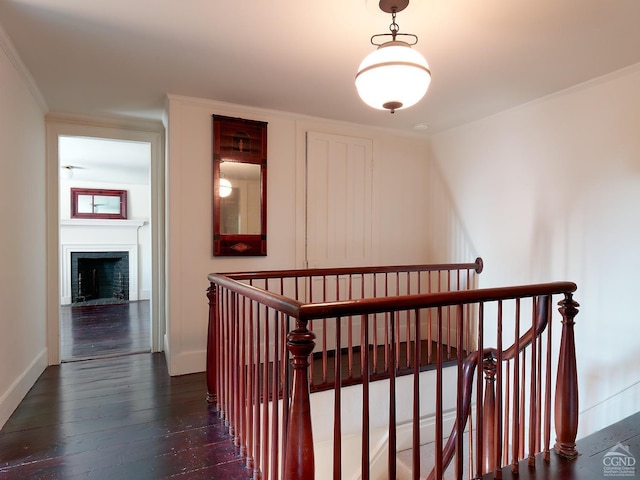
(0, 27, 47, 427)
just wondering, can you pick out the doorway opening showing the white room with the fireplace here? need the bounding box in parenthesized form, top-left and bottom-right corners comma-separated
(57, 135, 154, 362)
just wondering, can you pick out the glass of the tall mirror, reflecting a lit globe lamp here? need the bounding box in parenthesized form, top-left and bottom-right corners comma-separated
(219, 159, 262, 235)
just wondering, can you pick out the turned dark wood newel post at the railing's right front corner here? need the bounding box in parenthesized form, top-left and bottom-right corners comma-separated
(554, 293, 580, 458)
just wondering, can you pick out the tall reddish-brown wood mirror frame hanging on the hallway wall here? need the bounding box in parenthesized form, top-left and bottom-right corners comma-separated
(213, 115, 267, 256)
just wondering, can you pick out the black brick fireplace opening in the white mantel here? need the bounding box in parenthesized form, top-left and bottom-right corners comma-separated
(71, 252, 129, 303)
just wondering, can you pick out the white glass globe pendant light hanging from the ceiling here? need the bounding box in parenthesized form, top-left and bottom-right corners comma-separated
(356, 0, 431, 113)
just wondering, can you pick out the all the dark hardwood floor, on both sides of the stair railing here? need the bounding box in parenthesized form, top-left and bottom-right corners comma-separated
(0, 310, 640, 480)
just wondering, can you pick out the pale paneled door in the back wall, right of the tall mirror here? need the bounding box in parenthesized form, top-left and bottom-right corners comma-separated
(306, 132, 373, 268)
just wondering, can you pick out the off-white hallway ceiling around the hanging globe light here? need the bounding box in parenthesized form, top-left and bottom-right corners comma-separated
(0, 0, 640, 134)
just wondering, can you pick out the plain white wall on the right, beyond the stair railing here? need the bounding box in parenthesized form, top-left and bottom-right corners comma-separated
(432, 66, 640, 436)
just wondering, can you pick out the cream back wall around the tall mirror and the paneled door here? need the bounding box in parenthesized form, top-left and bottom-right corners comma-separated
(165, 95, 429, 375)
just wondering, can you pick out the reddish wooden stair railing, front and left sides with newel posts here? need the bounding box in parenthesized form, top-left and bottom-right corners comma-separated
(207, 264, 577, 480)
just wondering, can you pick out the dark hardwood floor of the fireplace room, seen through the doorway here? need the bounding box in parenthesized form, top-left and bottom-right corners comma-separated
(60, 300, 151, 362)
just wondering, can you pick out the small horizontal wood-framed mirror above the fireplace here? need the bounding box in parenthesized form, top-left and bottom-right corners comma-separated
(71, 188, 127, 220)
